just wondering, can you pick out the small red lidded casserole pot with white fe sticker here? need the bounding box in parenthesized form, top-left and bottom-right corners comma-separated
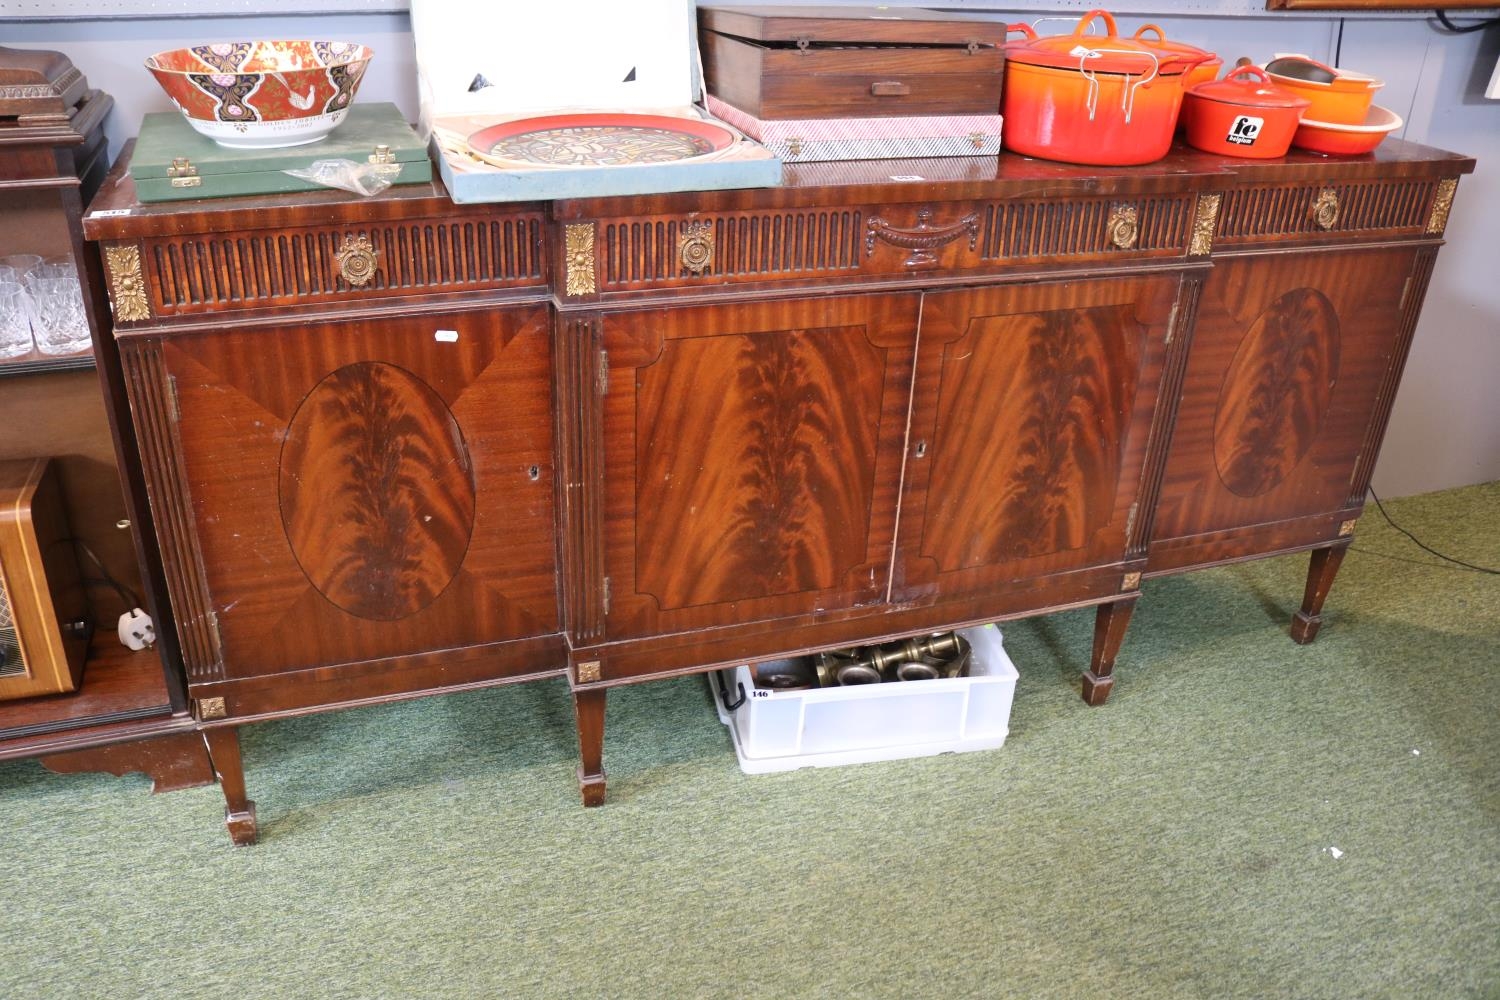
(1182, 66, 1311, 159)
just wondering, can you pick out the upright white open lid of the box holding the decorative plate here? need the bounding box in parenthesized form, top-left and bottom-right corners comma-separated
(411, 0, 696, 127)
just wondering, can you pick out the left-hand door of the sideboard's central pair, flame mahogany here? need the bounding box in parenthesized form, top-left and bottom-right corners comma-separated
(603, 294, 920, 640)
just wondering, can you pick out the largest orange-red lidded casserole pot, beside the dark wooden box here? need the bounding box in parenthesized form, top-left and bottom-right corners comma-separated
(1001, 10, 1208, 166)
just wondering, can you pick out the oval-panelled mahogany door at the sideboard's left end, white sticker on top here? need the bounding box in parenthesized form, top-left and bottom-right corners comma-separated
(147, 304, 558, 679)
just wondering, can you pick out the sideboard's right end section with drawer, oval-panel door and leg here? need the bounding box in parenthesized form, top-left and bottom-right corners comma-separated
(1148, 170, 1457, 642)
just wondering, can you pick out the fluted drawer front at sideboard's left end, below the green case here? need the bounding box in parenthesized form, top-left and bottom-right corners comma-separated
(114, 211, 546, 322)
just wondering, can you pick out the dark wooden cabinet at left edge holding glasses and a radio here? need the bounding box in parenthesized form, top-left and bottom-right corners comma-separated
(0, 48, 213, 790)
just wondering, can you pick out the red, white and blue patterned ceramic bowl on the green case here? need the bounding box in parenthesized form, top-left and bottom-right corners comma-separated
(146, 40, 374, 148)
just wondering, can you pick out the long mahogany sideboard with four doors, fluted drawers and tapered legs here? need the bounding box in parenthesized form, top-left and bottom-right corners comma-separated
(86, 141, 1473, 843)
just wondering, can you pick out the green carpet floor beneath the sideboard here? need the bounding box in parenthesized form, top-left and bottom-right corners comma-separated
(0, 483, 1500, 1000)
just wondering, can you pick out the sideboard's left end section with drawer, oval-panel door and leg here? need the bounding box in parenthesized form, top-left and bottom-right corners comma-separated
(92, 176, 566, 843)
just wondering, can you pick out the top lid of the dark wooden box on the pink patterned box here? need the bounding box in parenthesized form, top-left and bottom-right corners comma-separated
(698, 6, 1005, 48)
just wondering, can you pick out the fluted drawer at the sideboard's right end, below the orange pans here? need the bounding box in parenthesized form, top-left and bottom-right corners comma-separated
(1214, 177, 1458, 250)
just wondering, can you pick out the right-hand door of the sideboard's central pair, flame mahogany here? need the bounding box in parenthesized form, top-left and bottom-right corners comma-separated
(894, 274, 1179, 602)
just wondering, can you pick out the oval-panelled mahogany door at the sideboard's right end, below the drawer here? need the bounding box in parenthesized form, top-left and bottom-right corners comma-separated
(1151, 247, 1431, 571)
